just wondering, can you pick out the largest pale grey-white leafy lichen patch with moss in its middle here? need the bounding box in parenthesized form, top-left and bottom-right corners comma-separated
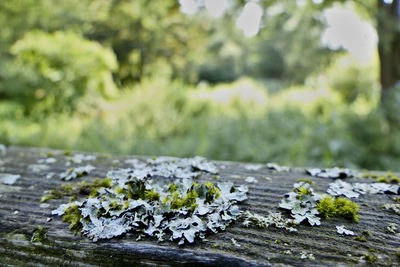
(53, 157, 247, 245)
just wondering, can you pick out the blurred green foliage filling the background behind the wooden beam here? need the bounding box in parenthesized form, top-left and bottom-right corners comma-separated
(0, 0, 400, 170)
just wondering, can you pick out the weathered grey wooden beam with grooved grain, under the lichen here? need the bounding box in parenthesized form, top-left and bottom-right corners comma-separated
(0, 147, 400, 266)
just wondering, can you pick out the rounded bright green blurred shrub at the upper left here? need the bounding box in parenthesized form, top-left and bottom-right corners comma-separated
(4, 31, 117, 115)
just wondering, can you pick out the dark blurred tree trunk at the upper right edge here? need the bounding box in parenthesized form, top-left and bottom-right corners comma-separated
(377, 0, 400, 104)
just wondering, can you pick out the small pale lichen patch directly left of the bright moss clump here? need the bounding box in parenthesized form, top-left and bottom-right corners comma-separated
(279, 182, 321, 226)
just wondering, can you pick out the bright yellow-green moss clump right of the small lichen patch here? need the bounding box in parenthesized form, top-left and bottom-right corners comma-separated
(317, 196, 359, 221)
